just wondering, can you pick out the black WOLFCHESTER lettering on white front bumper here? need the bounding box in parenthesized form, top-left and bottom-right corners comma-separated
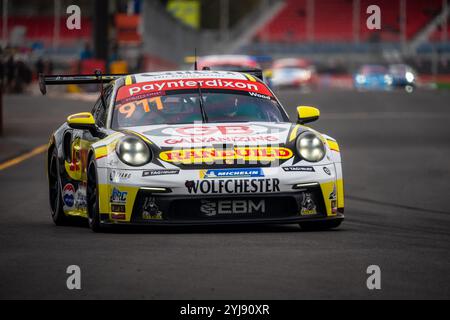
(185, 179, 280, 194)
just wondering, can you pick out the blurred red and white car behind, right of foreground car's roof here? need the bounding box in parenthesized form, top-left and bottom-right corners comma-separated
(270, 58, 317, 88)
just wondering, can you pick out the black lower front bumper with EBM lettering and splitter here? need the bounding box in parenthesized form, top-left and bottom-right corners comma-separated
(101, 183, 344, 226)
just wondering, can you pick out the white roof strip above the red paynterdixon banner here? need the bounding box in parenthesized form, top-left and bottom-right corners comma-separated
(124, 70, 253, 83)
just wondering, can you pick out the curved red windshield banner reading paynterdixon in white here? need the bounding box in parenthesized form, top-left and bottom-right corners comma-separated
(117, 79, 272, 100)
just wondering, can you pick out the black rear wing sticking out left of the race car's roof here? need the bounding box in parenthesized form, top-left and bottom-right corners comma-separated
(39, 72, 126, 95)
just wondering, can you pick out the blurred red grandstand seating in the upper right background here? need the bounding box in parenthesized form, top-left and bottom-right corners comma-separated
(255, 0, 443, 43)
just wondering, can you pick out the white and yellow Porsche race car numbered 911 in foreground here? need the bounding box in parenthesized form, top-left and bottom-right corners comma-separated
(40, 71, 344, 231)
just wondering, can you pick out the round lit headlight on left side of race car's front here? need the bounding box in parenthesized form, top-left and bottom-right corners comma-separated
(116, 136, 151, 167)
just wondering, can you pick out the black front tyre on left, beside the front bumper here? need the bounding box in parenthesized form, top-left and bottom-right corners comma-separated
(86, 158, 102, 232)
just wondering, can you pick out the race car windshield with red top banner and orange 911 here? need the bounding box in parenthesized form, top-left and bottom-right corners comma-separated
(112, 80, 288, 128)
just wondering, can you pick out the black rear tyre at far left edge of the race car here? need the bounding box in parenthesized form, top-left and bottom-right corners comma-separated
(48, 147, 69, 226)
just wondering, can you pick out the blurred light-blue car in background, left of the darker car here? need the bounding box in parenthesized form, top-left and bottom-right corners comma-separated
(354, 65, 393, 90)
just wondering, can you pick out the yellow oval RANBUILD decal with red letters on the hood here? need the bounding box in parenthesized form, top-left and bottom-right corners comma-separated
(159, 147, 293, 164)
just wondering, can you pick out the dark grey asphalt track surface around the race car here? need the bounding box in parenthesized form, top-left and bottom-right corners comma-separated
(0, 91, 450, 299)
